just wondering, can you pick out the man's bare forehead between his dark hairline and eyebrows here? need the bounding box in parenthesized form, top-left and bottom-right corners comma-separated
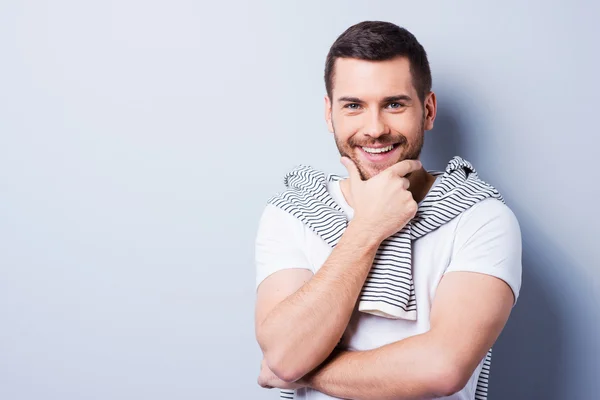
(332, 57, 415, 101)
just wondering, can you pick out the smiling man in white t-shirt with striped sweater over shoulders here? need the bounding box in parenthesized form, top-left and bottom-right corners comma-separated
(255, 21, 521, 399)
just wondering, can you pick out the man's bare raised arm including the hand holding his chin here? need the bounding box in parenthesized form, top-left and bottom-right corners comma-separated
(256, 159, 422, 382)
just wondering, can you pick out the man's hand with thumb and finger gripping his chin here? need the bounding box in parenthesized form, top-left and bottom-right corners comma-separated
(341, 157, 422, 241)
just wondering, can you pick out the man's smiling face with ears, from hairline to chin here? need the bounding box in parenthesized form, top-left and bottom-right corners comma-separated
(325, 57, 436, 180)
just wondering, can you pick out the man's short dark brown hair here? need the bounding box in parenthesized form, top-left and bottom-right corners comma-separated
(325, 21, 431, 102)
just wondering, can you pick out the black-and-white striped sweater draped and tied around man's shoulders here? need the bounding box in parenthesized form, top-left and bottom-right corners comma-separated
(268, 157, 504, 400)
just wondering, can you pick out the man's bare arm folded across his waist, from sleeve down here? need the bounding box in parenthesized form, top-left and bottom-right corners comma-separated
(299, 272, 514, 400)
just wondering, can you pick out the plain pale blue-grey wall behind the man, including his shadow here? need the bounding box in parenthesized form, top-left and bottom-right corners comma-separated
(0, 0, 600, 400)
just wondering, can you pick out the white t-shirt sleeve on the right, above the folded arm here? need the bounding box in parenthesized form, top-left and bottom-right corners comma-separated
(446, 198, 522, 307)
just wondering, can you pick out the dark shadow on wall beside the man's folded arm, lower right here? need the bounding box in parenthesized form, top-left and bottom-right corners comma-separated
(489, 223, 569, 400)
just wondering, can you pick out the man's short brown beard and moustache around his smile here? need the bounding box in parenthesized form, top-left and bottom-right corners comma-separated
(332, 118, 425, 181)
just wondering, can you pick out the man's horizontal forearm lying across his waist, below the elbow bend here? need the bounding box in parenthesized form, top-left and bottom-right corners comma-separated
(302, 334, 454, 400)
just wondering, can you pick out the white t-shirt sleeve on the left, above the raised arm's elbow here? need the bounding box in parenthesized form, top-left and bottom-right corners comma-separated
(254, 204, 314, 289)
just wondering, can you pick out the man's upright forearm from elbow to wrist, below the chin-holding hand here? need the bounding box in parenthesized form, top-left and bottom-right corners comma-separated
(257, 222, 380, 381)
